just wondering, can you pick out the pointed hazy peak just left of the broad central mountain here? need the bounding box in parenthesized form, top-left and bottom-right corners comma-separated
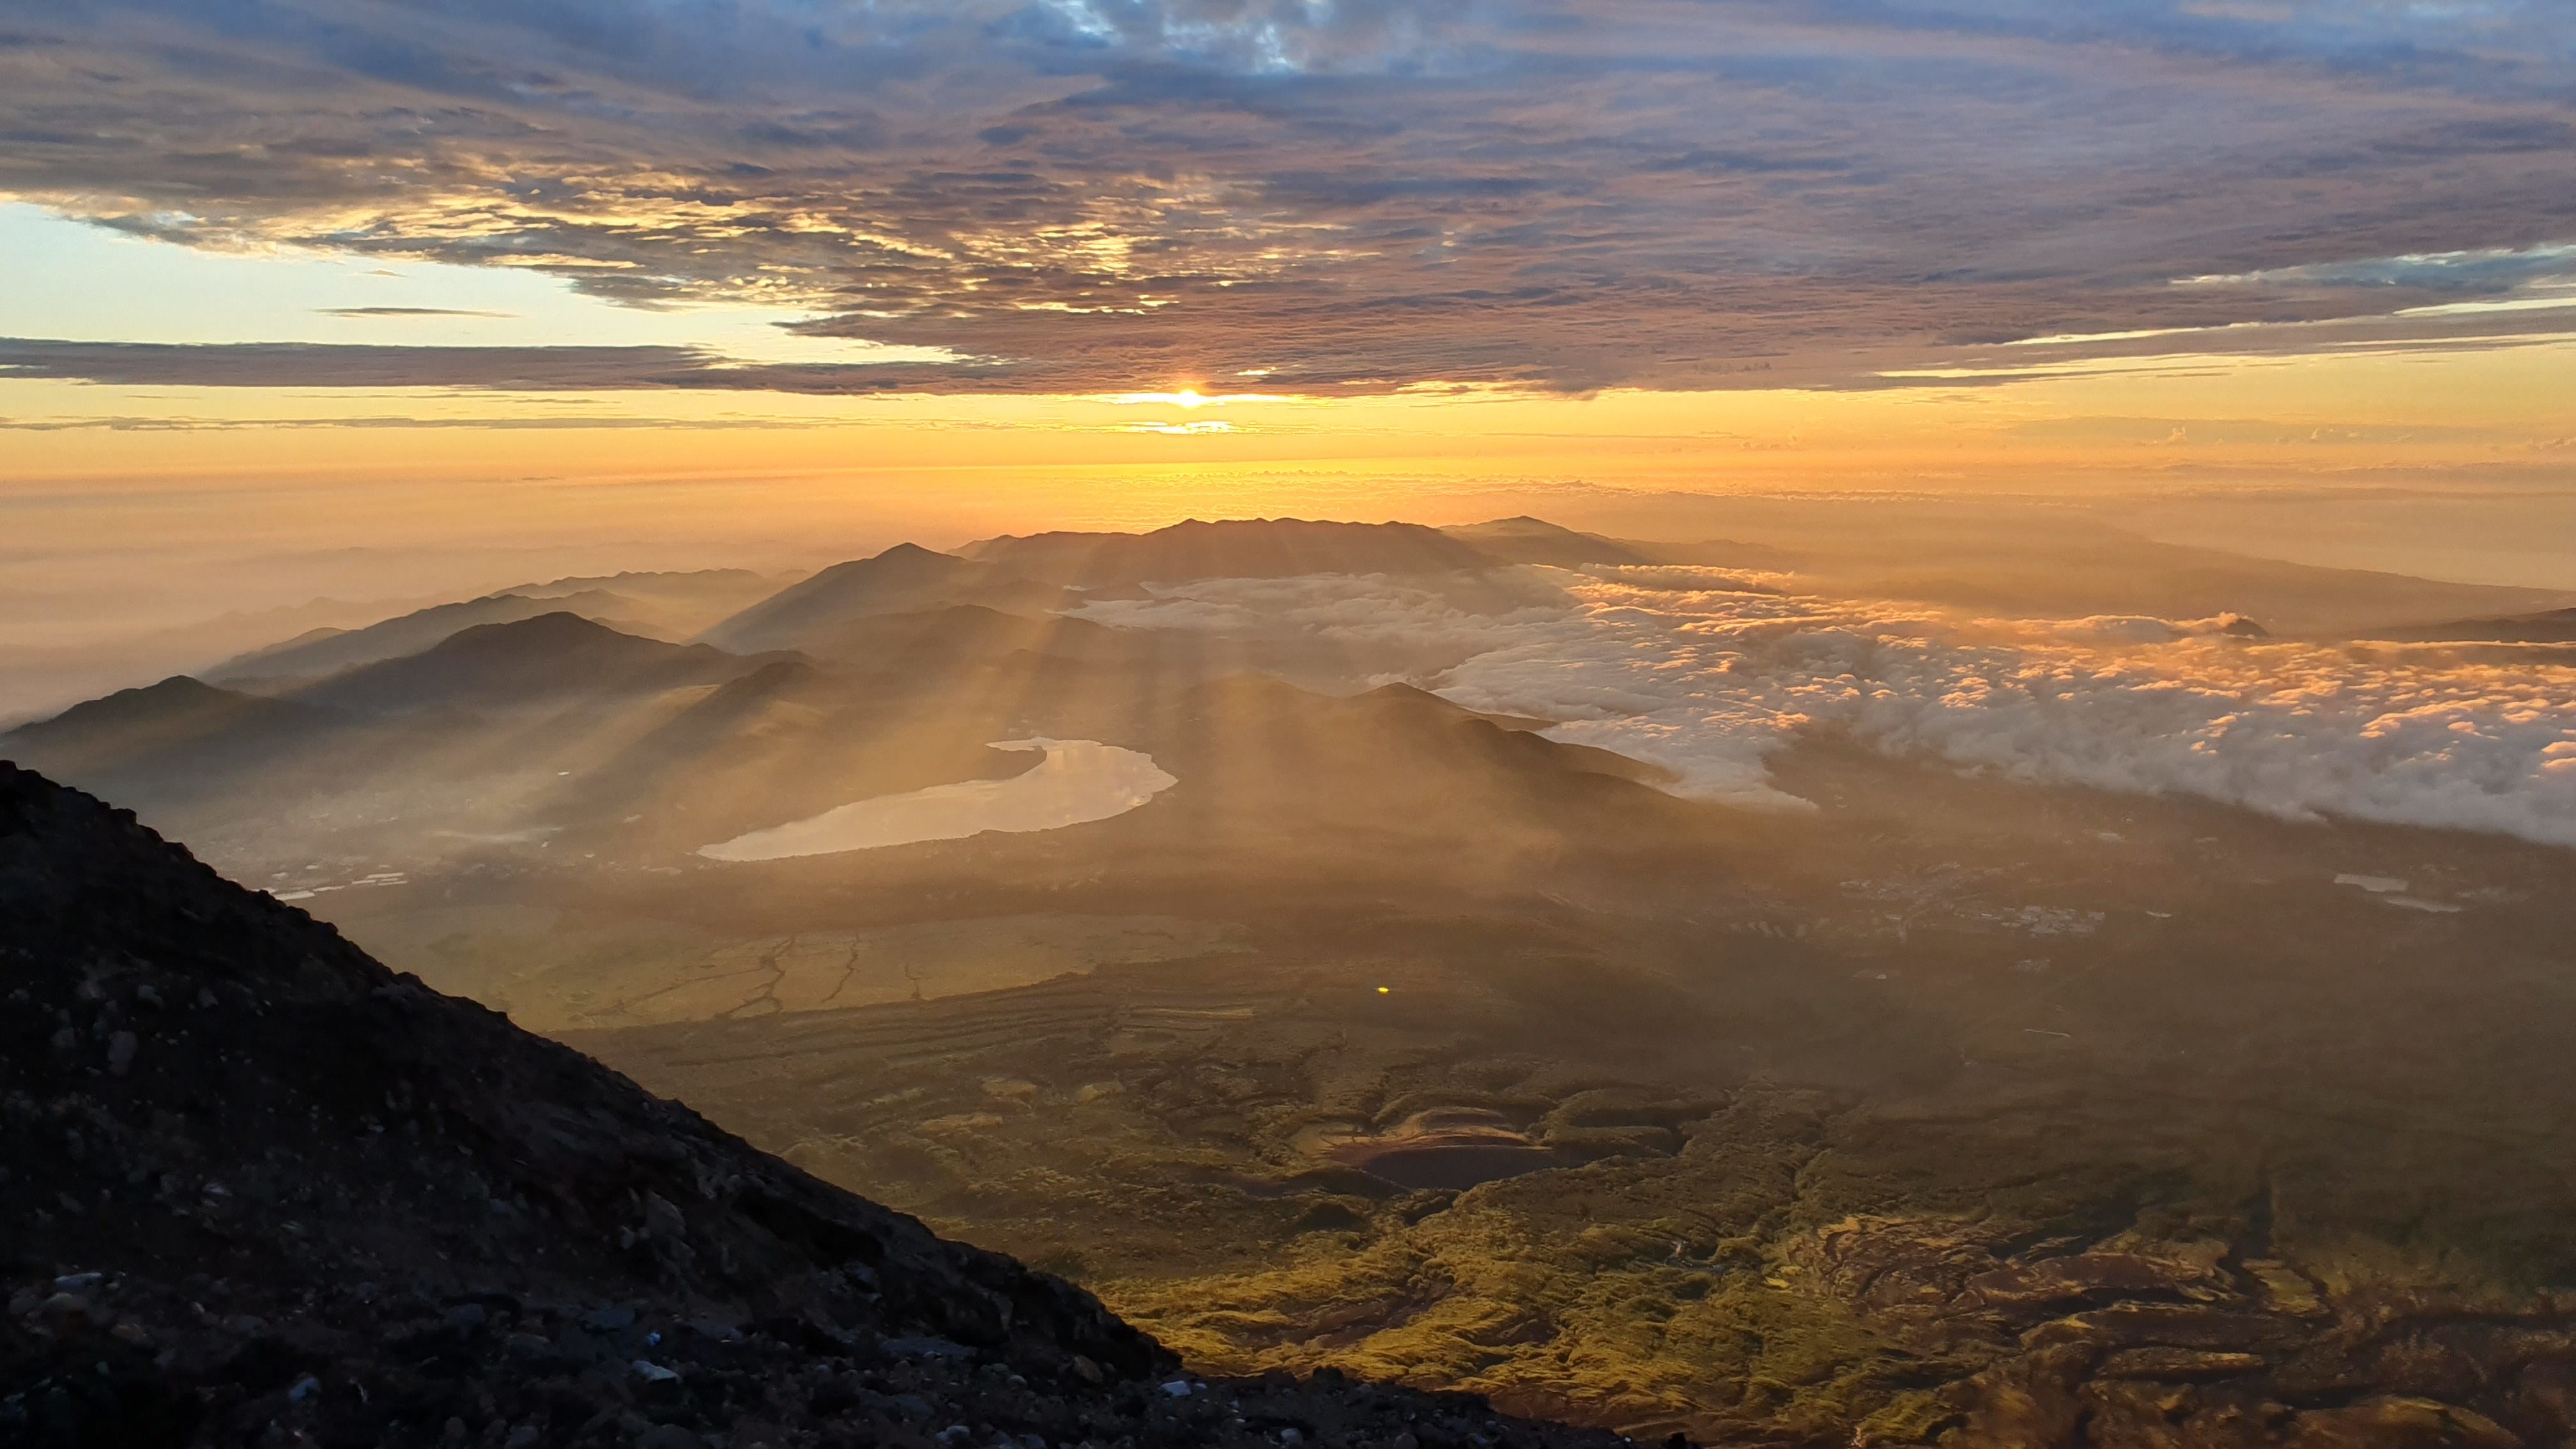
(703, 544, 1064, 655)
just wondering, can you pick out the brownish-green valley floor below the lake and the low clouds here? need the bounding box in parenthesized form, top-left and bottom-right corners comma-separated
(287, 745, 2576, 1444)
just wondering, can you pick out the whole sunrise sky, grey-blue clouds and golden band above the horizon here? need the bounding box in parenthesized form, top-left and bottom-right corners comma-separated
(0, 0, 2576, 627)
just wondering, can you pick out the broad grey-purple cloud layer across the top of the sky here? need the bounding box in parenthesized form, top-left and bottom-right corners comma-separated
(0, 0, 2576, 392)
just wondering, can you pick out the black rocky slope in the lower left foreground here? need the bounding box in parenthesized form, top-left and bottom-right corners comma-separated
(0, 763, 1615, 1449)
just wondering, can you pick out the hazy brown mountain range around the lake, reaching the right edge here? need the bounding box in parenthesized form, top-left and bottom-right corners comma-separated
(0, 518, 2566, 877)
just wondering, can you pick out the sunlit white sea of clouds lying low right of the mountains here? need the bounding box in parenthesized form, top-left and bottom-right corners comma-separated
(1084, 570, 2576, 846)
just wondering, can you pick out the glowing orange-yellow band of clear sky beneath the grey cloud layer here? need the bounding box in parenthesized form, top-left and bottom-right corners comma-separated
(0, 341, 2576, 552)
